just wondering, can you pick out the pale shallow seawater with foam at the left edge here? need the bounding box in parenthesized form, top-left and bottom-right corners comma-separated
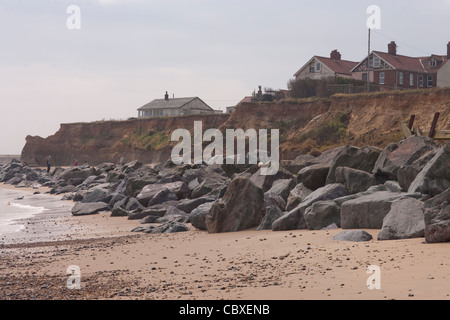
(0, 188, 46, 235)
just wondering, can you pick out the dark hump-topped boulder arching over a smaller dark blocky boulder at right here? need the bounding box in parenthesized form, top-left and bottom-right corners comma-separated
(326, 146, 381, 184)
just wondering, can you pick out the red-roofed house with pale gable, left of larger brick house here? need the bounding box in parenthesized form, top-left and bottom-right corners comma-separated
(294, 50, 358, 80)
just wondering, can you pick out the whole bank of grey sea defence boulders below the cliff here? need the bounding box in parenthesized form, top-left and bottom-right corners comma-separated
(0, 137, 450, 242)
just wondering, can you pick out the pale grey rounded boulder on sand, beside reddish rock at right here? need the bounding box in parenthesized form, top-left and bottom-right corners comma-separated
(378, 198, 425, 240)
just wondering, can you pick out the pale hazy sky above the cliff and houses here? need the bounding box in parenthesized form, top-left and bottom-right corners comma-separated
(0, 0, 450, 154)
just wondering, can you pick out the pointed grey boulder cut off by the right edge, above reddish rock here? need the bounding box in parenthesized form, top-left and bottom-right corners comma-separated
(408, 142, 450, 196)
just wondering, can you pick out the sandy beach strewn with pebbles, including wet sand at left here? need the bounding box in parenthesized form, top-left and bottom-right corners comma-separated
(0, 185, 450, 300)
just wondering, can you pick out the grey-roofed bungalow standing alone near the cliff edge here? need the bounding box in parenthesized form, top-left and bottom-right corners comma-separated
(138, 92, 219, 119)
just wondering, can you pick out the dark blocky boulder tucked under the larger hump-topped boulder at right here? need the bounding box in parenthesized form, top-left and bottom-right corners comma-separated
(336, 167, 378, 194)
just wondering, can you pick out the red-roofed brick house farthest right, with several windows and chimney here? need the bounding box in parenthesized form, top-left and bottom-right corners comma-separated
(351, 41, 450, 90)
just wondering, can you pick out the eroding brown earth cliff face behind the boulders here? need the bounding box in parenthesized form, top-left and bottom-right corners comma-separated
(21, 89, 450, 166)
